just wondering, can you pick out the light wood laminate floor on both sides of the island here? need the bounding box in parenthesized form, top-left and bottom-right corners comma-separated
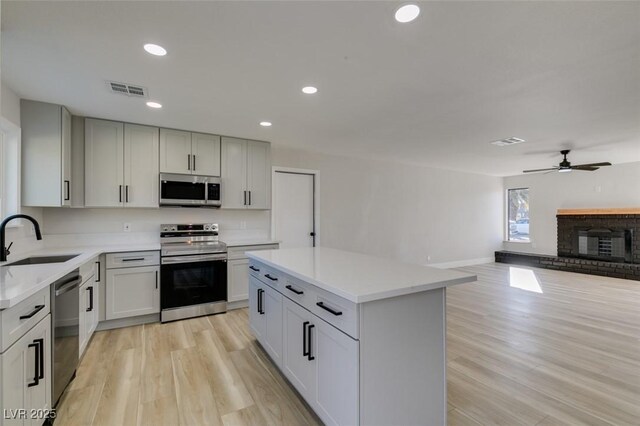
(56, 264, 640, 426)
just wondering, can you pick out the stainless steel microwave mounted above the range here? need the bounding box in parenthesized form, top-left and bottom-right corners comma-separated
(160, 173, 222, 207)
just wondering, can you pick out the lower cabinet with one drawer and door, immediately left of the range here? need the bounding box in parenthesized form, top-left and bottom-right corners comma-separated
(105, 251, 160, 320)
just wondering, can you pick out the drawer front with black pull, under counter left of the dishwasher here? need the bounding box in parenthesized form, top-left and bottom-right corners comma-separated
(0, 286, 51, 352)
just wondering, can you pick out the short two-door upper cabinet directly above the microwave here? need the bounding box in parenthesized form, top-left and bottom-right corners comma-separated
(160, 129, 220, 176)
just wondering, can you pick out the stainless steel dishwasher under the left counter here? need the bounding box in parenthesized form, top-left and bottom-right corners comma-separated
(51, 269, 82, 407)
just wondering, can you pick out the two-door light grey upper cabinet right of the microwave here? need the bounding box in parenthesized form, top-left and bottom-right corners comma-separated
(222, 137, 271, 210)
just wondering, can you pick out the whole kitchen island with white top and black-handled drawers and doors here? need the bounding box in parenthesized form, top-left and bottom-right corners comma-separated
(247, 247, 476, 425)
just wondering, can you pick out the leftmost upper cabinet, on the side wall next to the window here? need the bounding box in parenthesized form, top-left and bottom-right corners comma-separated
(20, 99, 73, 207)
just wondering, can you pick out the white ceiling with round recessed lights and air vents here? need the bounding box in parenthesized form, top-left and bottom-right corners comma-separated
(1, 1, 640, 176)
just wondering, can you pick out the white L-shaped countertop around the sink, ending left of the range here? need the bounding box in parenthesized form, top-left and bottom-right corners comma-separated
(0, 244, 160, 309)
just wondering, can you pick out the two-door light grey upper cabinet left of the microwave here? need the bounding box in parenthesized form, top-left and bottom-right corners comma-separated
(84, 118, 159, 207)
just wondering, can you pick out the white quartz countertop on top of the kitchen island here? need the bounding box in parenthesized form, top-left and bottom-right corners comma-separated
(246, 247, 477, 303)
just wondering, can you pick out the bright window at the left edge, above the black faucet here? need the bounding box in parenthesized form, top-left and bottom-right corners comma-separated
(0, 117, 20, 219)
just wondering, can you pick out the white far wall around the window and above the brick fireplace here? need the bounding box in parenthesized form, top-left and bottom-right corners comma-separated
(503, 159, 640, 255)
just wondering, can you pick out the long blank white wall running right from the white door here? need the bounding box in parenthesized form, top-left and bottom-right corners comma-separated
(272, 145, 503, 264)
